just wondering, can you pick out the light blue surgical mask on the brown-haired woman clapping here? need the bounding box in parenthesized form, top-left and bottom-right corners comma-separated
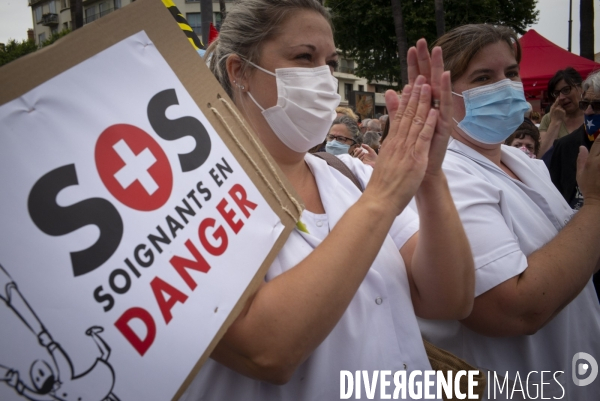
(452, 79, 529, 145)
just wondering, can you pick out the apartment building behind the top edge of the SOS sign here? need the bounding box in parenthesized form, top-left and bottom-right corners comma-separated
(29, 0, 233, 45)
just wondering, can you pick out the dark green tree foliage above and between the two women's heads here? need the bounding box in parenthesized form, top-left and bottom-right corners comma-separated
(325, 0, 539, 88)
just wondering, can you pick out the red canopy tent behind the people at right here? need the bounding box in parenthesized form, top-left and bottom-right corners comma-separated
(519, 29, 600, 97)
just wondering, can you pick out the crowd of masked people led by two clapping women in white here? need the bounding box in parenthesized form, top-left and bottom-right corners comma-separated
(176, 0, 600, 401)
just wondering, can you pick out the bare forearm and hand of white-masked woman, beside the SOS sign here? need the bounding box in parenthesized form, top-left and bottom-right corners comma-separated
(212, 79, 437, 384)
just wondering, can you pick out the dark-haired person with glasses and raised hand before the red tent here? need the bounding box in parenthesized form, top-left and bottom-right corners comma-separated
(539, 67, 583, 157)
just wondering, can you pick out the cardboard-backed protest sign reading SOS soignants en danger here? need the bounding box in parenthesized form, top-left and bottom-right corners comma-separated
(0, 0, 301, 401)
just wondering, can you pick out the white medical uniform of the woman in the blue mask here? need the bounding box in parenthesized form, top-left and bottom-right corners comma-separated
(419, 140, 600, 401)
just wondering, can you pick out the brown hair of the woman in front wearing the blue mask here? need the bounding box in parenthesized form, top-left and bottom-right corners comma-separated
(434, 24, 521, 82)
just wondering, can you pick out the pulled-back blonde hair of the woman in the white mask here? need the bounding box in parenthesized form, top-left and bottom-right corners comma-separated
(204, 0, 333, 97)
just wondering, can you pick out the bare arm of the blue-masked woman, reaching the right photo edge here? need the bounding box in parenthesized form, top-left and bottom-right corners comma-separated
(463, 141, 600, 337)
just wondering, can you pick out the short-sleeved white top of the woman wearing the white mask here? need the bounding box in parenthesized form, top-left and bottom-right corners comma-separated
(181, 155, 431, 401)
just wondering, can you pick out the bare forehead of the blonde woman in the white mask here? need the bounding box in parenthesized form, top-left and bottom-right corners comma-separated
(270, 10, 335, 53)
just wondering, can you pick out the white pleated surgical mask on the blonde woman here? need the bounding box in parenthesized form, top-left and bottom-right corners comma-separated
(243, 61, 340, 153)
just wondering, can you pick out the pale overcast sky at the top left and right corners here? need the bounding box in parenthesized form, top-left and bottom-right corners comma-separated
(0, 0, 600, 54)
